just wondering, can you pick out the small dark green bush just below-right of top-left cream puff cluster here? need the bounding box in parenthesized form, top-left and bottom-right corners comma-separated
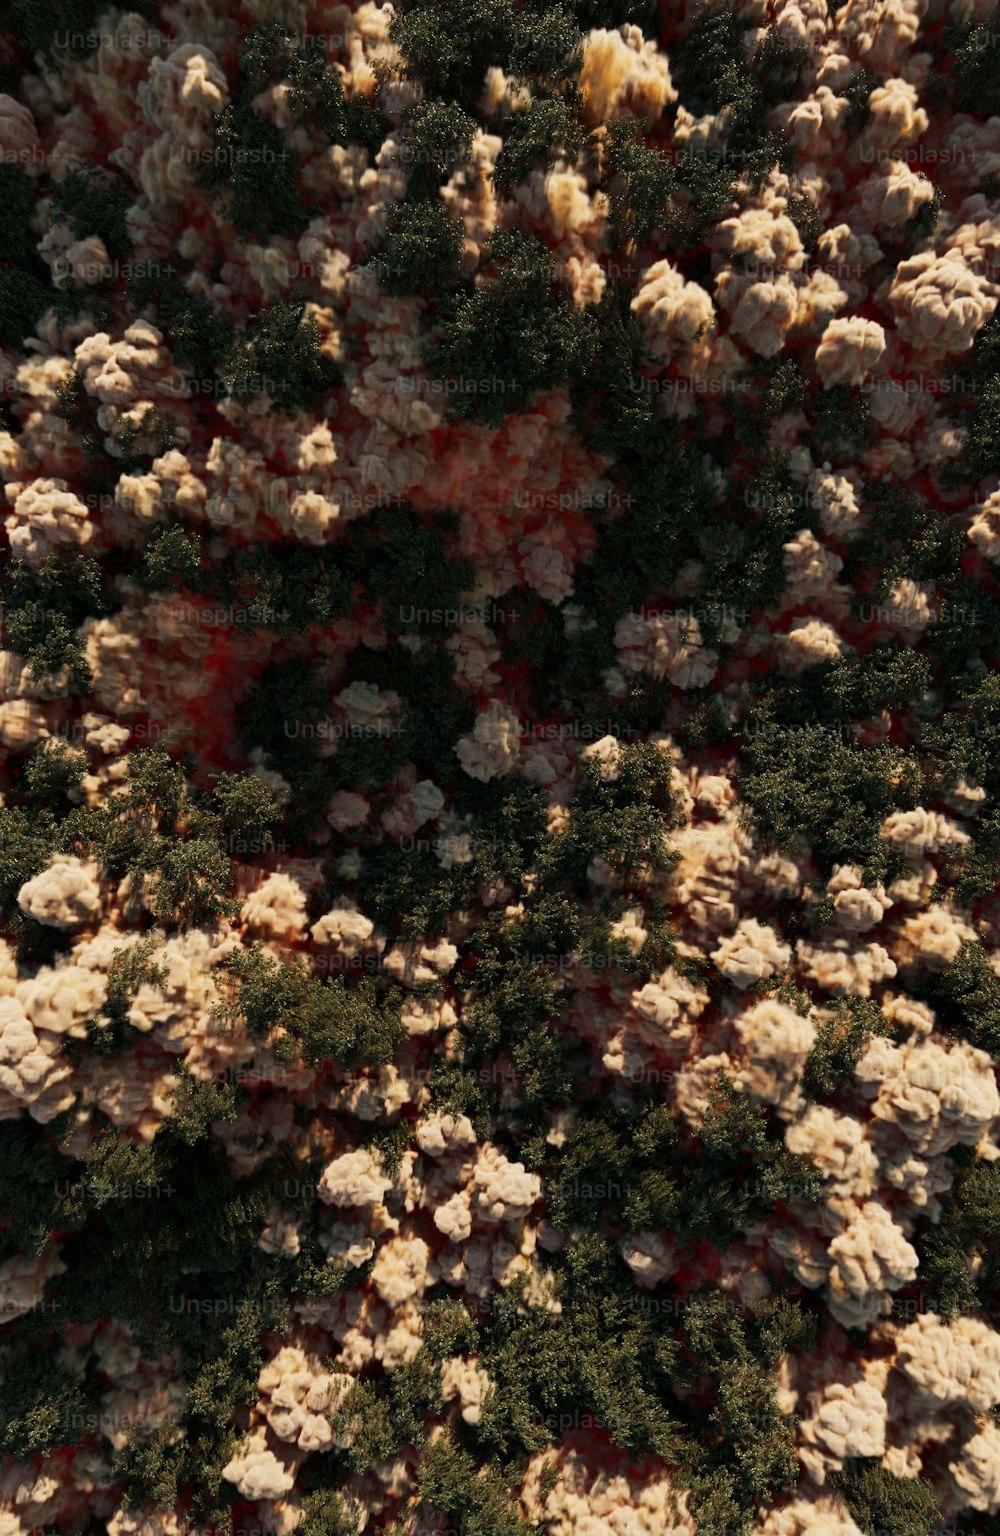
(197, 101, 309, 241)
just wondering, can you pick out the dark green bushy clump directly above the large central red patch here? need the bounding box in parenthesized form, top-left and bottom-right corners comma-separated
(427, 230, 596, 427)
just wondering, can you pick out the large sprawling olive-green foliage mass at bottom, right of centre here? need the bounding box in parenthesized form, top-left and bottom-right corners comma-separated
(476, 1230, 814, 1536)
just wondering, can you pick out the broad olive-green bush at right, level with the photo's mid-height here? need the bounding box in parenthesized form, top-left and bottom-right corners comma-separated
(740, 725, 920, 879)
